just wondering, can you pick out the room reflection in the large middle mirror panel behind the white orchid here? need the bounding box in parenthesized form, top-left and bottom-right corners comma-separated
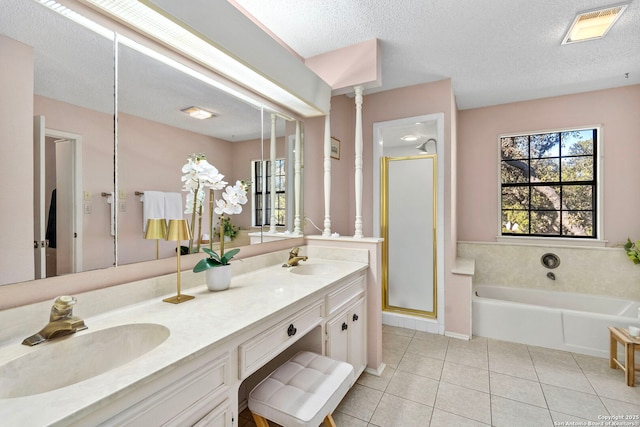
(117, 37, 270, 264)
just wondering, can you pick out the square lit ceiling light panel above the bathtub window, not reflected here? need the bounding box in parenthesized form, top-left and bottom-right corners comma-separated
(562, 4, 628, 44)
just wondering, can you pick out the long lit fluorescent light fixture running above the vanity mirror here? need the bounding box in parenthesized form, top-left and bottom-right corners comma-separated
(85, 0, 320, 117)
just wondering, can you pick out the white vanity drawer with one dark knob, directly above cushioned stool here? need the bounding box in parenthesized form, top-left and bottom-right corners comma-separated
(238, 301, 322, 379)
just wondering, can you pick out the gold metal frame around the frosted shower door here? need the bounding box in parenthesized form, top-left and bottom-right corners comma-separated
(380, 154, 438, 318)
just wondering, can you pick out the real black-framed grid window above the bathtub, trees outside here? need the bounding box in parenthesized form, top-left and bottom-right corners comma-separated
(500, 129, 598, 239)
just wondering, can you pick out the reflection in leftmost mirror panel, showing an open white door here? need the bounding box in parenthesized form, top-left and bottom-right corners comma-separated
(0, 0, 115, 284)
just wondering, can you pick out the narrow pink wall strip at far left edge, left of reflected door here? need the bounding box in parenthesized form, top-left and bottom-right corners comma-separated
(0, 36, 34, 284)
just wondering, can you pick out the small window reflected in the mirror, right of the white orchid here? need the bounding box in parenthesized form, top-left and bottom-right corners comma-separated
(252, 159, 287, 227)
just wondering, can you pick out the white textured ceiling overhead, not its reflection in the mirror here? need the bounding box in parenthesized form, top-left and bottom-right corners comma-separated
(234, 0, 640, 109)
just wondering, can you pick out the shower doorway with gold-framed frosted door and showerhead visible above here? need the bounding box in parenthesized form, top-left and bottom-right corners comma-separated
(373, 113, 444, 333)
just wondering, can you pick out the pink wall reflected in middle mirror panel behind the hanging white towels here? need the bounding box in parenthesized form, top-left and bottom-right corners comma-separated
(118, 114, 245, 264)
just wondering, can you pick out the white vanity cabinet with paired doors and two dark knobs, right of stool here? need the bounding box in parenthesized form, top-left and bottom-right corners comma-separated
(325, 273, 367, 378)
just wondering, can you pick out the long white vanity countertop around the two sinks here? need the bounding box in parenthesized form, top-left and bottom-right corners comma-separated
(0, 259, 367, 427)
